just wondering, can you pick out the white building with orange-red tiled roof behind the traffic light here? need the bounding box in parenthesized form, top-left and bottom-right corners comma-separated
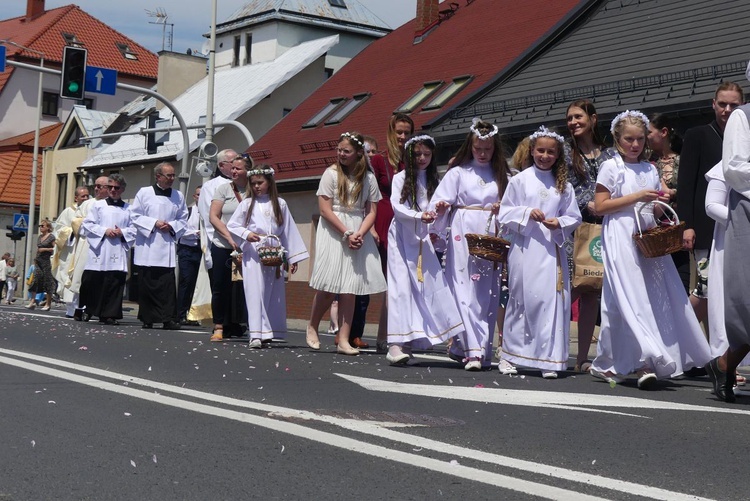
(0, 0, 159, 139)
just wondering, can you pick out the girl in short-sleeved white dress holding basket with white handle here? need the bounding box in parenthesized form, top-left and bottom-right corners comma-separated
(591, 111, 711, 390)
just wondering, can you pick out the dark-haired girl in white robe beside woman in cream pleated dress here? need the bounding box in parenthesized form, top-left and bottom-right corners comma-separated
(386, 135, 463, 365)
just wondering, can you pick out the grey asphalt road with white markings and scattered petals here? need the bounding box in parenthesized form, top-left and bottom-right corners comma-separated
(0, 306, 750, 501)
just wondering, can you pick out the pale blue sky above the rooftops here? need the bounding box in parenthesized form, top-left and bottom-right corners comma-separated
(5, 0, 417, 52)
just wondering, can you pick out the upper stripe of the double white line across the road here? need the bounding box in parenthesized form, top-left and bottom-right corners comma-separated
(0, 348, 710, 501)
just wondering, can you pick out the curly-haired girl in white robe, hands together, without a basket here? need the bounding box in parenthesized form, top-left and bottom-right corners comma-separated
(497, 126, 581, 379)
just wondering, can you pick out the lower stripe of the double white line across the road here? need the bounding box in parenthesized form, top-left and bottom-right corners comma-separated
(0, 357, 602, 501)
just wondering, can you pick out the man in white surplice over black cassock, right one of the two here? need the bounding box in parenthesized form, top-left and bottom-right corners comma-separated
(130, 162, 188, 330)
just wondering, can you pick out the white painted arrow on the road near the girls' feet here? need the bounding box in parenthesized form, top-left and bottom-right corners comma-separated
(336, 374, 750, 418)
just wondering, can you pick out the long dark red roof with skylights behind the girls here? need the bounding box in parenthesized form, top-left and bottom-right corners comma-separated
(251, 0, 585, 184)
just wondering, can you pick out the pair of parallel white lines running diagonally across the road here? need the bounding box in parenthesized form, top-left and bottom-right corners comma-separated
(0, 349, 711, 501)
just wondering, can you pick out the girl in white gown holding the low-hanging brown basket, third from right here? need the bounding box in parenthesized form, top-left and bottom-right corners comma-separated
(430, 118, 510, 371)
